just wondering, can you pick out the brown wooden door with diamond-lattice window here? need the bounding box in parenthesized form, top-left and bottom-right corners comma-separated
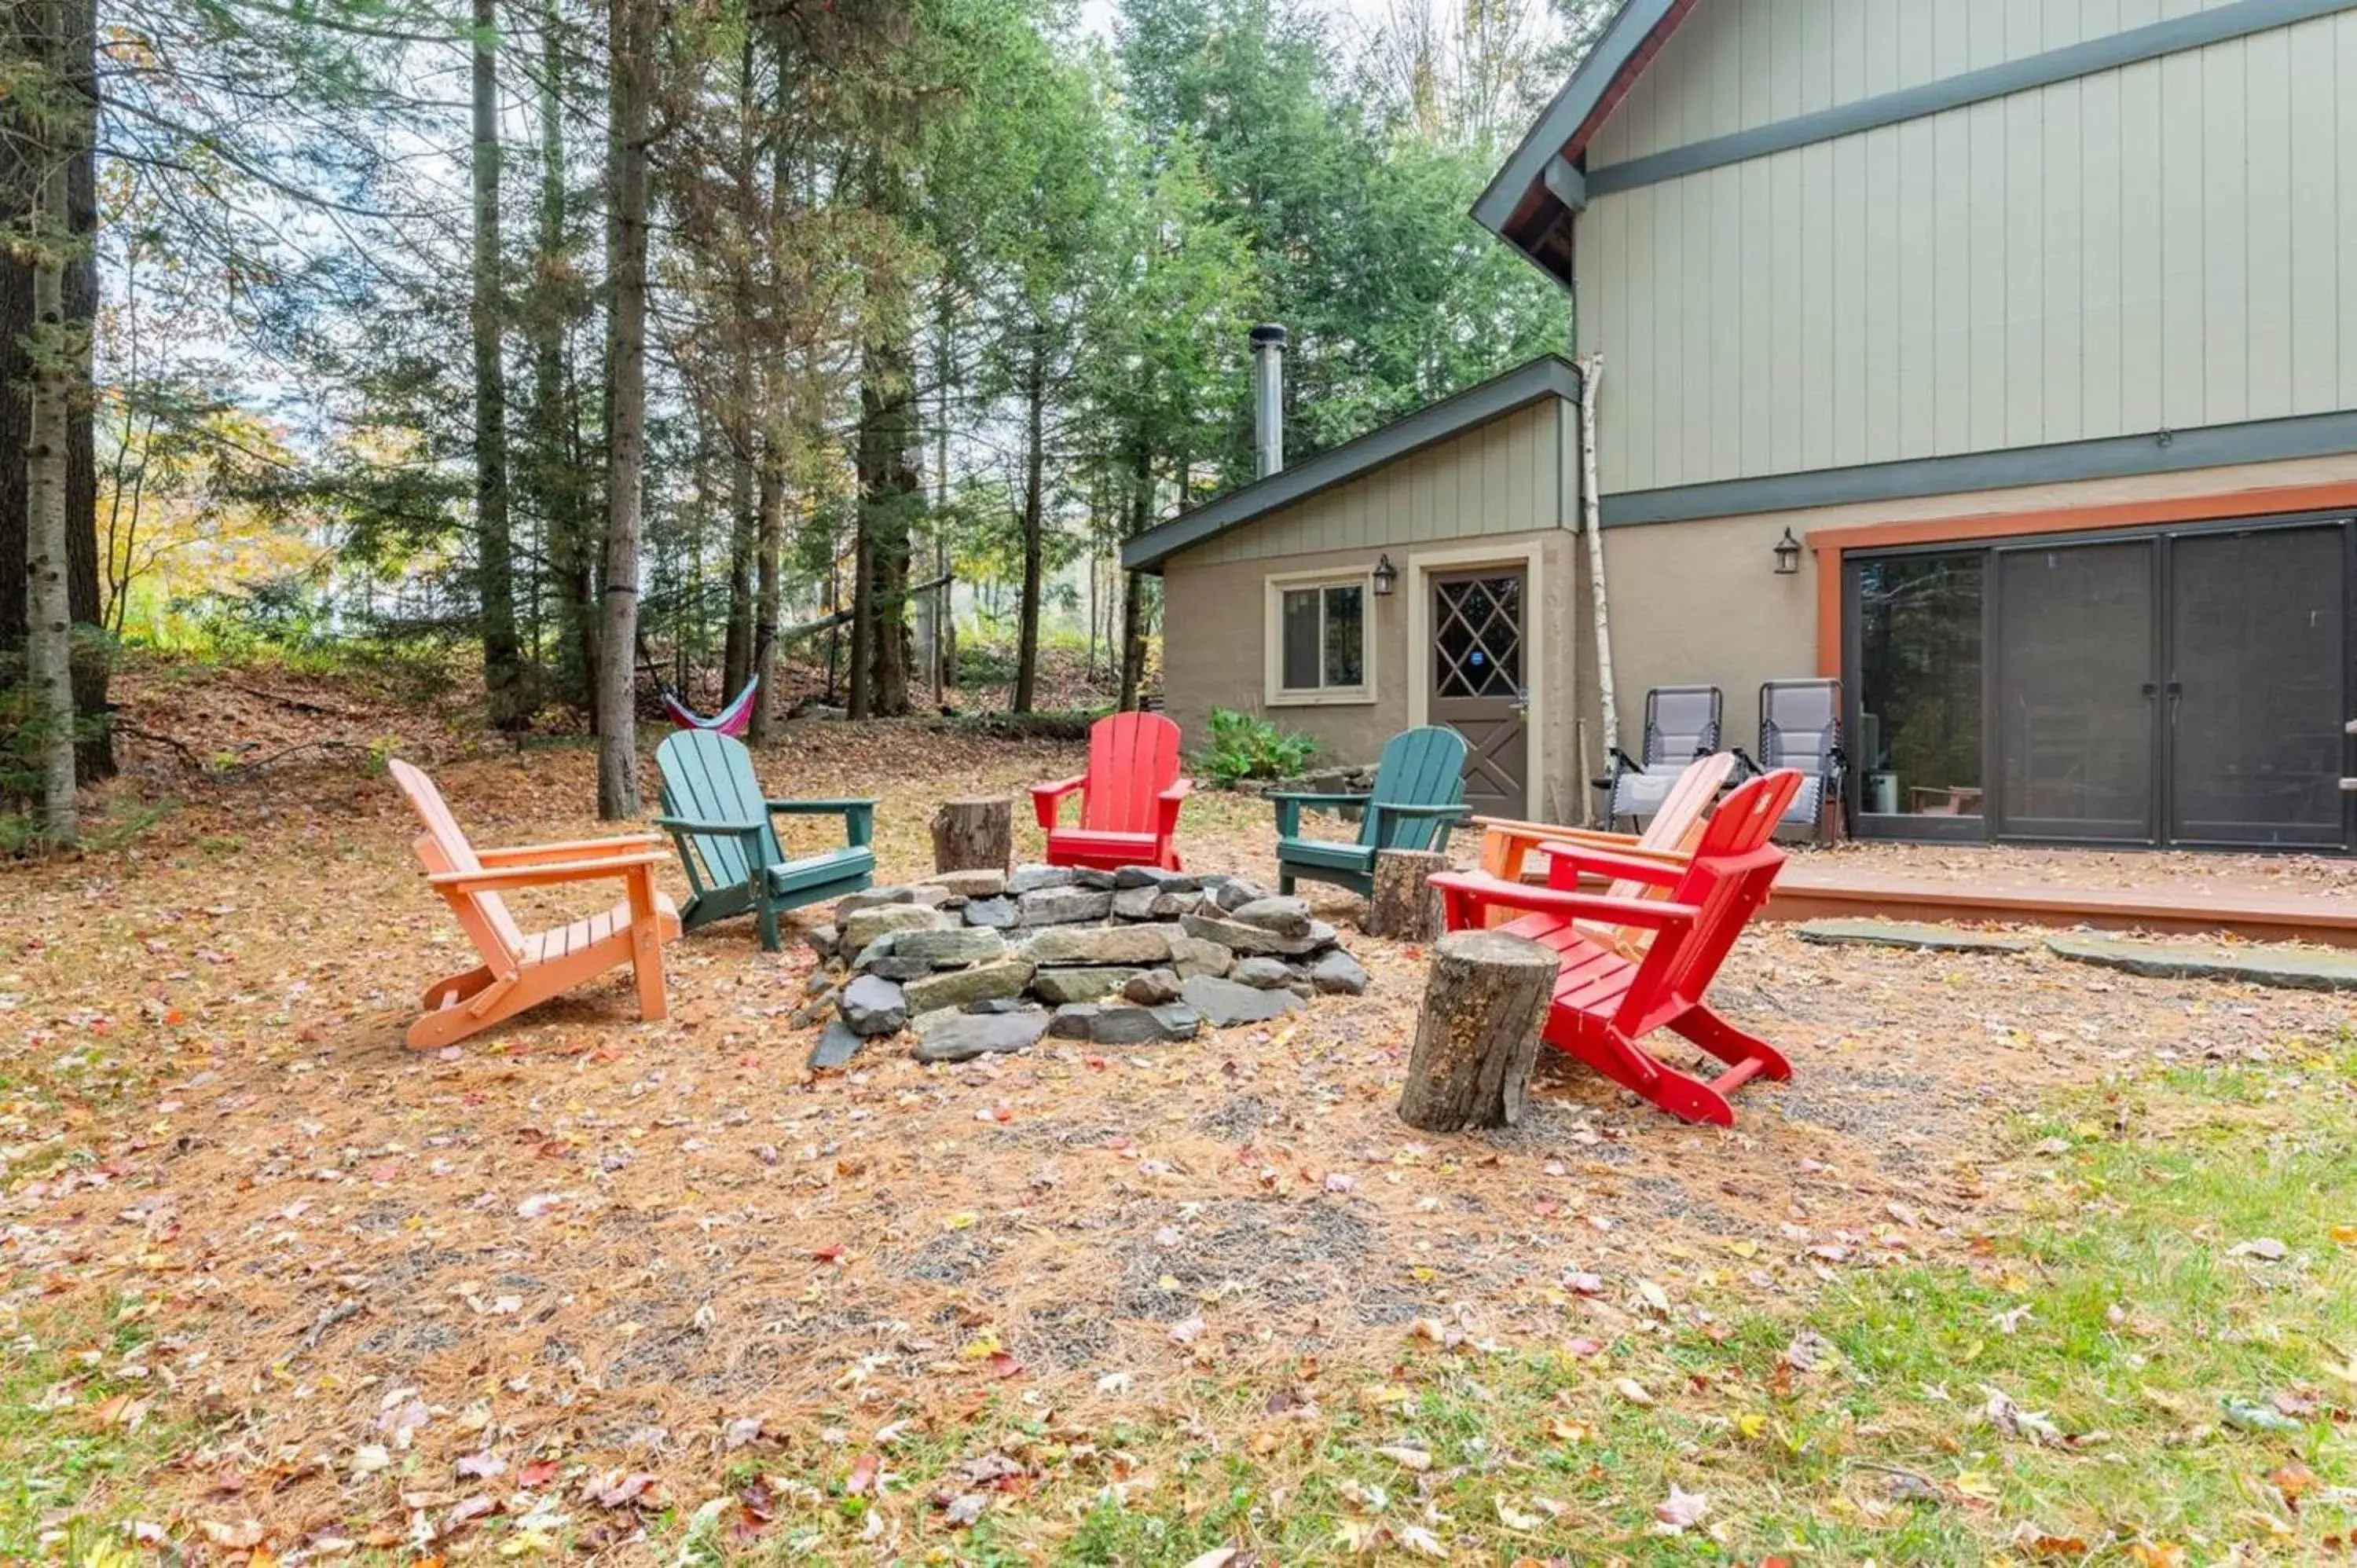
(1426, 566, 1532, 816)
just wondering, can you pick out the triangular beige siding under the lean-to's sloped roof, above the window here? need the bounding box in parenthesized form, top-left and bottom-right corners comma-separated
(1188, 398, 1579, 573)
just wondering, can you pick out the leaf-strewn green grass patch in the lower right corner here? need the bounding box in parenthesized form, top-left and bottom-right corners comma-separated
(669, 1054, 2357, 1566)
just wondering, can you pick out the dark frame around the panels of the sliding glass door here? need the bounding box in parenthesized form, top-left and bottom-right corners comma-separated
(1841, 509, 2357, 854)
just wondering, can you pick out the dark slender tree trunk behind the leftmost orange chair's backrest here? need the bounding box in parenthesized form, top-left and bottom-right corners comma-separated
(471, 0, 533, 728)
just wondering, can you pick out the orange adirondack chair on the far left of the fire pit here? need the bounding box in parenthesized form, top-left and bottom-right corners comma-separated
(391, 759, 679, 1052)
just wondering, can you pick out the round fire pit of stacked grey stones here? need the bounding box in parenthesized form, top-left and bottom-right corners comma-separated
(801, 866, 1367, 1068)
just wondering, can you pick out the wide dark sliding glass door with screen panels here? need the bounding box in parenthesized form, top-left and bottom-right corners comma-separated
(1846, 518, 2357, 849)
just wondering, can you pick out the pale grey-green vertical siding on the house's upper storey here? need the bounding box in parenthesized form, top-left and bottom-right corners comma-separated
(1577, 0, 2357, 495)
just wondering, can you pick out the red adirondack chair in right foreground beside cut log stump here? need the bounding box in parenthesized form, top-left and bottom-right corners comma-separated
(1433, 768, 1801, 1127)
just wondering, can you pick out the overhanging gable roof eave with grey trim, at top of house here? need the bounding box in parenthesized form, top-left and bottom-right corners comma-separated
(1473, 0, 1695, 283)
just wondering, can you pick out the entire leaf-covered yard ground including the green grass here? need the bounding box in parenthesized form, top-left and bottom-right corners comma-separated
(0, 655, 2357, 1568)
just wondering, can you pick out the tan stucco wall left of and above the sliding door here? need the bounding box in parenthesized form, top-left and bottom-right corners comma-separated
(1605, 455, 2357, 754)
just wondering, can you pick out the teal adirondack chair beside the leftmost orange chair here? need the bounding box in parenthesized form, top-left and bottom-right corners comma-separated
(655, 728, 877, 953)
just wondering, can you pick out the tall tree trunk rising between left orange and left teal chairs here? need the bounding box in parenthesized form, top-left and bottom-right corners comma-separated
(596, 0, 655, 821)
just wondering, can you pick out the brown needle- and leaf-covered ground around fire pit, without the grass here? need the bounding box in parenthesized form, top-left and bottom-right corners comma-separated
(0, 665, 2350, 1542)
